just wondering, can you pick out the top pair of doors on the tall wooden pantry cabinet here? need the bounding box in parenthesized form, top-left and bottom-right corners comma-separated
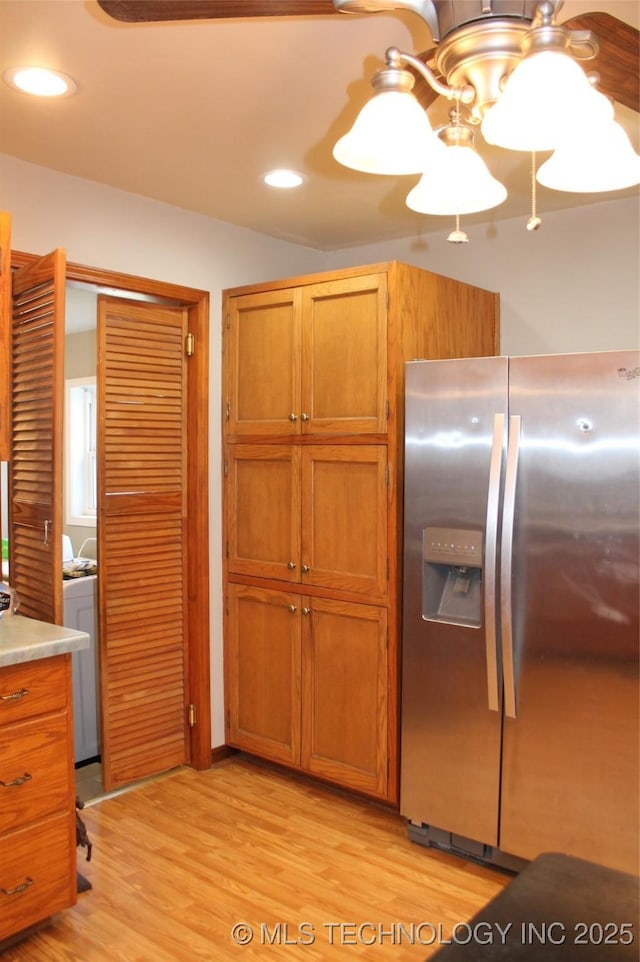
(225, 273, 387, 436)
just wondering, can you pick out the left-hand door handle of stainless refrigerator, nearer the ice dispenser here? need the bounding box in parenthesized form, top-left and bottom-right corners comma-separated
(484, 414, 506, 711)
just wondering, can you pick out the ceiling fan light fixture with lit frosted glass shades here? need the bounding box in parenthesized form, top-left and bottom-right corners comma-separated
(333, 0, 640, 242)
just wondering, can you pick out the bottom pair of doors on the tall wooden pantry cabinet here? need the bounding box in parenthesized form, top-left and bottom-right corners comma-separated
(227, 583, 388, 796)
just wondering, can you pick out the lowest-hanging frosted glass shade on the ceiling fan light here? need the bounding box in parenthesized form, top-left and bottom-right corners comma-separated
(407, 145, 507, 215)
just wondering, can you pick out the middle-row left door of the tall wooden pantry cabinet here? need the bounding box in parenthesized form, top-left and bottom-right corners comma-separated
(226, 444, 300, 581)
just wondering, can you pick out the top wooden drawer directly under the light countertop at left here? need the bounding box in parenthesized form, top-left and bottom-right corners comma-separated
(0, 655, 69, 725)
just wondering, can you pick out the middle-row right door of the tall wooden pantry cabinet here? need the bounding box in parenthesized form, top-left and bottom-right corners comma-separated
(301, 444, 387, 601)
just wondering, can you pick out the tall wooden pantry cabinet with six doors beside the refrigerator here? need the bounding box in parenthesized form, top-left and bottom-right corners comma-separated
(222, 261, 499, 804)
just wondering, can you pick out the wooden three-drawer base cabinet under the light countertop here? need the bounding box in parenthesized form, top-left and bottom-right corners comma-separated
(0, 654, 77, 942)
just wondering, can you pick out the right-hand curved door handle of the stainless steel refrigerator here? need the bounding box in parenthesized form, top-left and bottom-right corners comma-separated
(500, 414, 521, 718)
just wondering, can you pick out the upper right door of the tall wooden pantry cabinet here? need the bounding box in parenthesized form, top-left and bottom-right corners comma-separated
(301, 274, 387, 434)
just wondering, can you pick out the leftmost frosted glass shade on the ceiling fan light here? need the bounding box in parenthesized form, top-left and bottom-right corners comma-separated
(333, 90, 439, 175)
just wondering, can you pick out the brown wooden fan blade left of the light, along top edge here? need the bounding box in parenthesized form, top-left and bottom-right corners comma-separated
(98, 0, 336, 23)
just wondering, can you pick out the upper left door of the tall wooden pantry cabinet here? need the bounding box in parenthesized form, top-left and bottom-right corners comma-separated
(224, 289, 301, 435)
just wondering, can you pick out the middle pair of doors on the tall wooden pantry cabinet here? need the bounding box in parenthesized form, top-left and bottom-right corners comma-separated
(226, 444, 389, 601)
